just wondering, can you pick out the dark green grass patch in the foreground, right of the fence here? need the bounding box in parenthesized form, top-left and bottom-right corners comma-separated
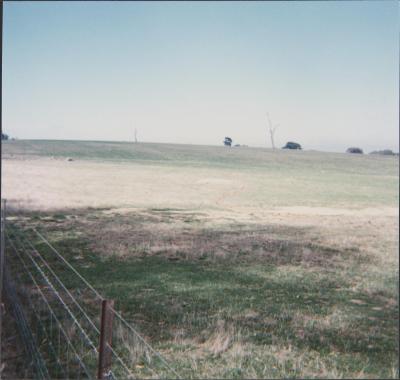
(28, 235, 398, 361)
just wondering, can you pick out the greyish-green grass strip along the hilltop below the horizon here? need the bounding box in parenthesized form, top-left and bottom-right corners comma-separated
(3, 140, 398, 175)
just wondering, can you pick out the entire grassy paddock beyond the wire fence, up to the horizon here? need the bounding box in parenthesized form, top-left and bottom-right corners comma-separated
(2, 141, 399, 378)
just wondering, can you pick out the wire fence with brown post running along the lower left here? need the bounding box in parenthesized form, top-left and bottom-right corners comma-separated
(0, 201, 180, 379)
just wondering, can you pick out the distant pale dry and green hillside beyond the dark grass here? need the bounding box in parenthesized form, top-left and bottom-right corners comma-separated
(3, 141, 398, 210)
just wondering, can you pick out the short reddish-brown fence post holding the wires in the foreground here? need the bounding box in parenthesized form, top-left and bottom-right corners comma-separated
(97, 300, 114, 379)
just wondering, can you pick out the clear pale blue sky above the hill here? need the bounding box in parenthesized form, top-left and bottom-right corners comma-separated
(2, 0, 399, 152)
